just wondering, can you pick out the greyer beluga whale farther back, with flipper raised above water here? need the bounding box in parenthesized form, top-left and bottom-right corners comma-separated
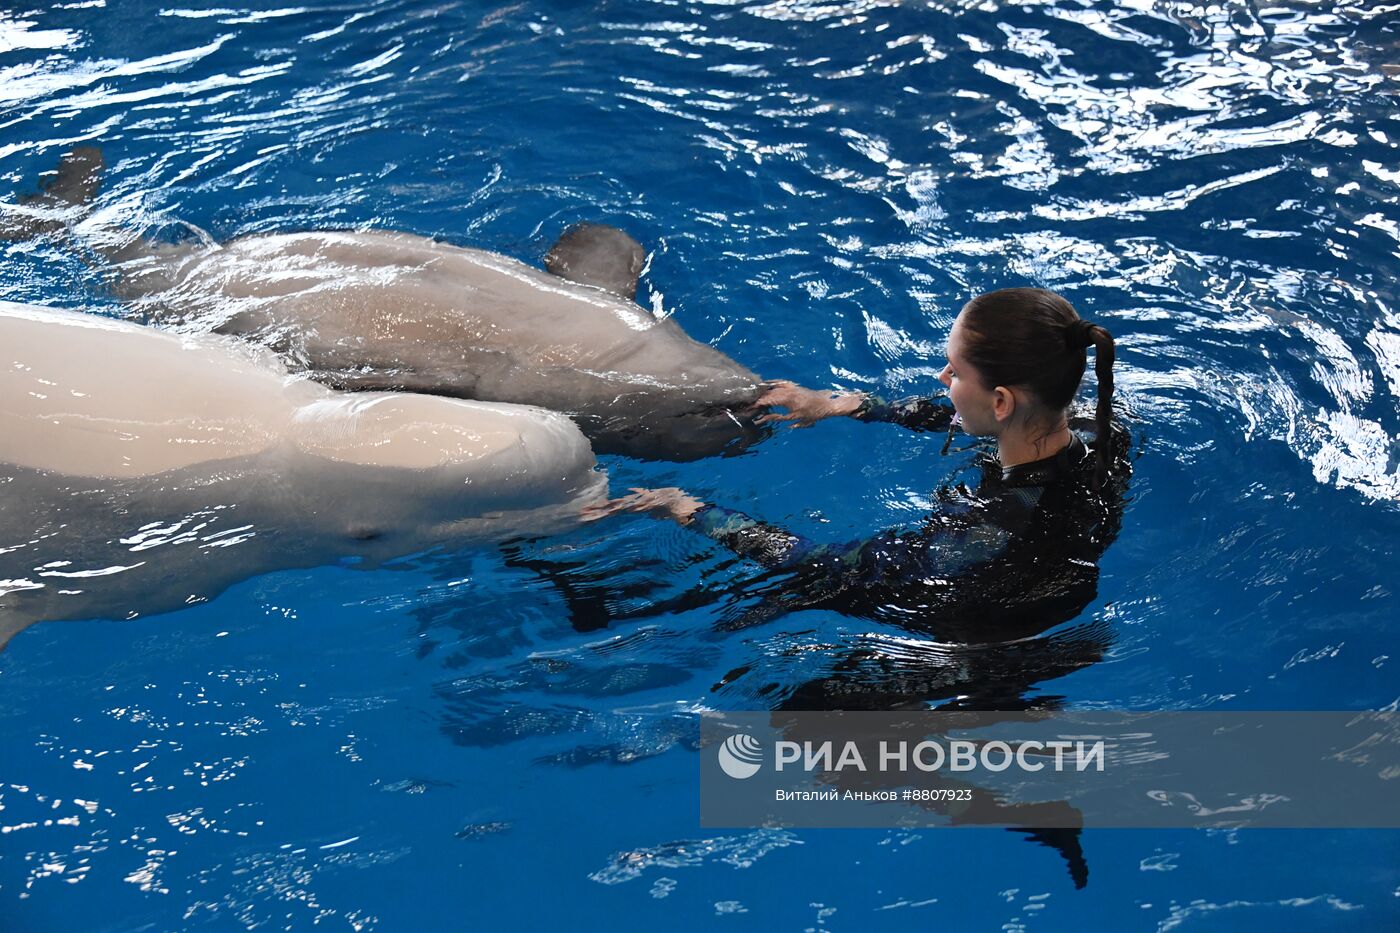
(11, 148, 766, 459)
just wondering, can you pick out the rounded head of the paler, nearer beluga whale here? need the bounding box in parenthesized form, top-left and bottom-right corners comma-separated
(286, 392, 606, 556)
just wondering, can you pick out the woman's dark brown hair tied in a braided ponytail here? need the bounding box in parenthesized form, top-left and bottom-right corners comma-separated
(962, 289, 1114, 489)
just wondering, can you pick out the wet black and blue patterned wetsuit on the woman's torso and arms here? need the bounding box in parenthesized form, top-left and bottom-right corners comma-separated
(689, 396, 1128, 642)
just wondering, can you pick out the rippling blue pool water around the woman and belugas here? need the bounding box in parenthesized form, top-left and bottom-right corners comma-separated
(0, 0, 1400, 932)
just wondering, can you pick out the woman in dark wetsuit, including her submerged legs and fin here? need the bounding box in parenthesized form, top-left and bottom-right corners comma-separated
(585, 289, 1130, 888)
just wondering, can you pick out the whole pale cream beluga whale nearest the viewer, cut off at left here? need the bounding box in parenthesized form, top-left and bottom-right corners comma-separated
(0, 303, 606, 646)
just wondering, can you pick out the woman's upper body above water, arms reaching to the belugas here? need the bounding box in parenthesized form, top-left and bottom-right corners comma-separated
(585, 289, 1128, 642)
